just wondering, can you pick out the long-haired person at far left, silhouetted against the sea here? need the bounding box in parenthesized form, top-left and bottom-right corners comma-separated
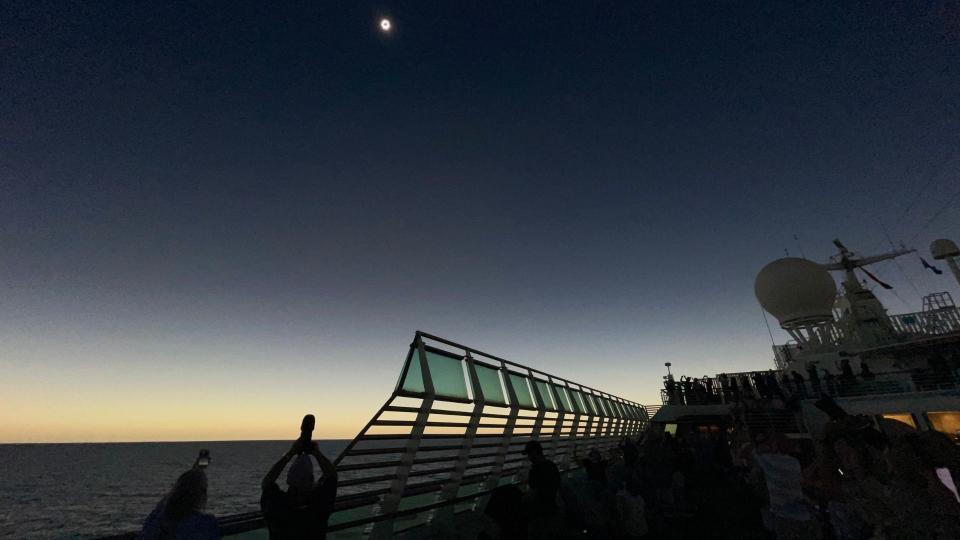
(138, 465, 220, 540)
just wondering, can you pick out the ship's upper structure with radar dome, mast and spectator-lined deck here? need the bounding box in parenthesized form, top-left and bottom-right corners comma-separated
(653, 240, 960, 441)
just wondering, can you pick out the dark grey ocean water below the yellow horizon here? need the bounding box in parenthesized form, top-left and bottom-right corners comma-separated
(0, 440, 349, 539)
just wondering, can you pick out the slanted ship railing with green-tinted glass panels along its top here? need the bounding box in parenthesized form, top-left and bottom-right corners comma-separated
(95, 331, 649, 539)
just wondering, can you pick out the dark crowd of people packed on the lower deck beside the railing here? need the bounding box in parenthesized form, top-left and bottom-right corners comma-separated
(481, 399, 960, 540)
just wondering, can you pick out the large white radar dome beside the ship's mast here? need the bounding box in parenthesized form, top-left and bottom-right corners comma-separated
(753, 257, 837, 328)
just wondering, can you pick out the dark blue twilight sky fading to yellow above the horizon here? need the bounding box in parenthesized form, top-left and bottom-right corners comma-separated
(0, 0, 960, 442)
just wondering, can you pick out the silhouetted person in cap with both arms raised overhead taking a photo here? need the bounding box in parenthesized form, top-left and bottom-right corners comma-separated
(260, 439, 337, 540)
